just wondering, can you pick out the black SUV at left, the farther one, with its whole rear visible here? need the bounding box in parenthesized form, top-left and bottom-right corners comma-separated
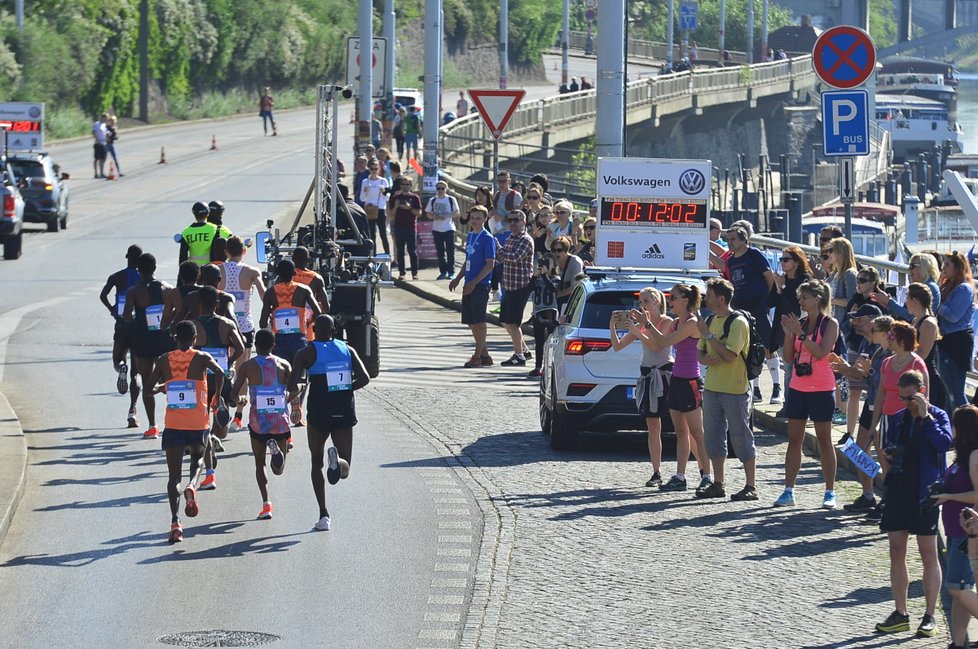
(7, 152, 68, 232)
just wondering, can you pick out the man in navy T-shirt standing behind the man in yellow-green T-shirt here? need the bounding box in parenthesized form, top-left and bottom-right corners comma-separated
(707, 226, 781, 403)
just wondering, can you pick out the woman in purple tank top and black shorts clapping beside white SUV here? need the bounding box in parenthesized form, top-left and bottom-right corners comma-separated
(643, 284, 713, 491)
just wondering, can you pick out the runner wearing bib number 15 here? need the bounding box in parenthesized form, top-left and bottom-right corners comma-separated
(231, 329, 292, 520)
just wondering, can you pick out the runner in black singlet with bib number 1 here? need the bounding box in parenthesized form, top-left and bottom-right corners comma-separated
(122, 252, 173, 439)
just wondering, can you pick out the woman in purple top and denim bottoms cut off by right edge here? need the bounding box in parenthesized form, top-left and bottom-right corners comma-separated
(931, 405, 978, 649)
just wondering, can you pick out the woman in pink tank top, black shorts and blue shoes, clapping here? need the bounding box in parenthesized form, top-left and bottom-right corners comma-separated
(774, 279, 839, 509)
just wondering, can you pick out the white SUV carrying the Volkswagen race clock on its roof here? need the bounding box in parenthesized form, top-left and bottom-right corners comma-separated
(540, 269, 714, 449)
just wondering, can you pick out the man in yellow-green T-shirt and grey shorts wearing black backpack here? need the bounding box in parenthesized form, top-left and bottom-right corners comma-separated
(696, 277, 759, 501)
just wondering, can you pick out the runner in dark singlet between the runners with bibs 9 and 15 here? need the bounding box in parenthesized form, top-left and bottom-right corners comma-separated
(193, 286, 244, 490)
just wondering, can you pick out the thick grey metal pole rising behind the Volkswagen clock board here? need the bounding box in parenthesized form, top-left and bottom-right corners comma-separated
(592, 0, 625, 157)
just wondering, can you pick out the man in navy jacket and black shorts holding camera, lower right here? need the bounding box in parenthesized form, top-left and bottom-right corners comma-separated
(876, 370, 951, 638)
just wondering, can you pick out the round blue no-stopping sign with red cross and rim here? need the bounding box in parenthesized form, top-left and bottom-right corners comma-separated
(812, 25, 876, 88)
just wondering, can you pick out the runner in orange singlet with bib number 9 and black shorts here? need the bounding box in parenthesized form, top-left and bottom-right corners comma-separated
(146, 320, 224, 543)
